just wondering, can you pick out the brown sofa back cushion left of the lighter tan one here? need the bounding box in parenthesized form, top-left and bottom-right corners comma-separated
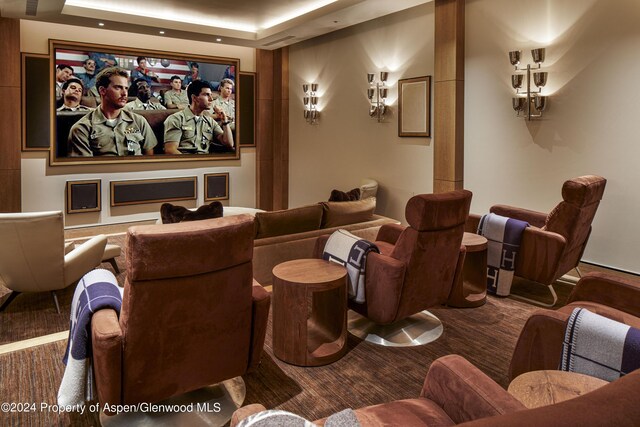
(256, 204, 322, 239)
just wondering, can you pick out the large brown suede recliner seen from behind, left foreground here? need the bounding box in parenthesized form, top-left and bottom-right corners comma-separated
(91, 215, 271, 412)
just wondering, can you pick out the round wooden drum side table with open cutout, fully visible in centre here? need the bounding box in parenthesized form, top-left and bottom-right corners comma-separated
(272, 259, 347, 366)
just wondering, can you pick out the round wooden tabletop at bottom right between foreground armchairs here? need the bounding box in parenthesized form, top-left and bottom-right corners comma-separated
(508, 370, 609, 408)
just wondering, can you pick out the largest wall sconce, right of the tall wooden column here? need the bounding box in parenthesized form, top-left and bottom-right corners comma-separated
(509, 48, 548, 120)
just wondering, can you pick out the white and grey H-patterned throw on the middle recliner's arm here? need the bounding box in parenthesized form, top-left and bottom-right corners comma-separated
(322, 229, 380, 304)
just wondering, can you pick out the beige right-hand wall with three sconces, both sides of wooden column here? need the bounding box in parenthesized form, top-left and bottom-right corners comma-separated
(290, 0, 640, 272)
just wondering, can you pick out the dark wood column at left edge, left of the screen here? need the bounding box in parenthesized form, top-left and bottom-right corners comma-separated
(0, 18, 22, 212)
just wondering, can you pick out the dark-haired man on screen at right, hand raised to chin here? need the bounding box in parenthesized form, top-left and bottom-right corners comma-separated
(164, 80, 234, 154)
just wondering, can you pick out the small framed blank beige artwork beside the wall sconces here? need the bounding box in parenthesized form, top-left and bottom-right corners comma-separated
(398, 76, 431, 137)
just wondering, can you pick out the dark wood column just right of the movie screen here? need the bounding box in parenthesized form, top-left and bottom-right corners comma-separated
(256, 47, 289, 210)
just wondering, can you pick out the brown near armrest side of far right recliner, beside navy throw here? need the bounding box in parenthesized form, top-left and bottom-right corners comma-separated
(515, 227, 567, 285)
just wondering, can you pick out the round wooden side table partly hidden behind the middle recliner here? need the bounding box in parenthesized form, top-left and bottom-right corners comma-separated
(447, 232, 487, 307)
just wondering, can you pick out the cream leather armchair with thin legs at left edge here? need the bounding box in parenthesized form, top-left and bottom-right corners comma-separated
(0, 211, 107, 313)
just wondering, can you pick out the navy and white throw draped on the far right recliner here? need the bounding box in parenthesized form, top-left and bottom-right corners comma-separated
(478, 213, 529, 296)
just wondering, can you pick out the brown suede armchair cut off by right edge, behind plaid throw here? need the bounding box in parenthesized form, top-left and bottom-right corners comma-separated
(509, 273, 640, 379)
